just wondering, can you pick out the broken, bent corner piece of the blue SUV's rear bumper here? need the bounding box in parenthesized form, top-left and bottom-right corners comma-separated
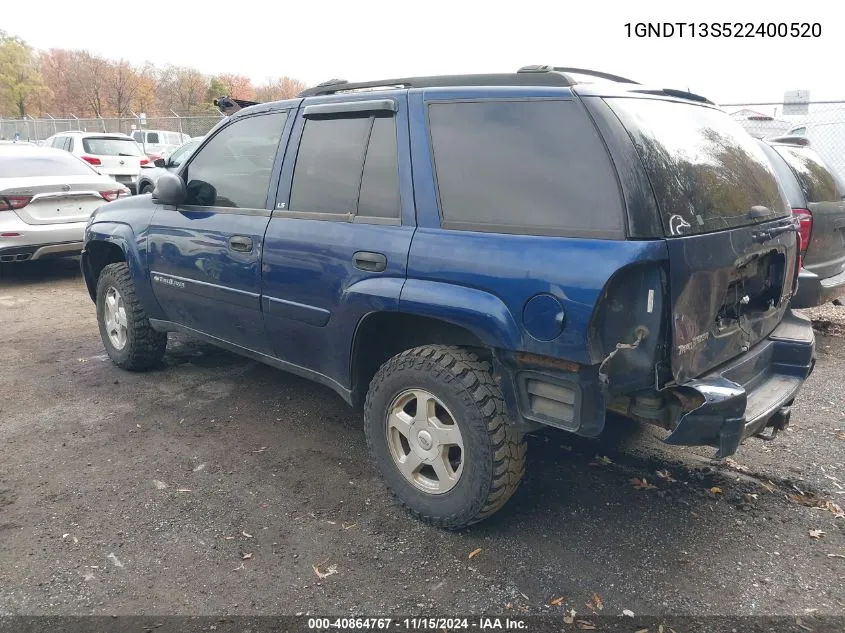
(665, 377, 748, 459)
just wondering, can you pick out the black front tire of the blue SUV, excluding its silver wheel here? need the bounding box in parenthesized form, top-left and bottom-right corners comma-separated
(97, 262, 167, 371)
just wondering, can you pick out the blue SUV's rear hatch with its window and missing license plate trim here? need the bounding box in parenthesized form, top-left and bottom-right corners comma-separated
(605, 97, 798, 383)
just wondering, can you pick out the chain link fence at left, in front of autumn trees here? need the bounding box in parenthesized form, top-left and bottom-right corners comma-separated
(0, 114, 223, 142)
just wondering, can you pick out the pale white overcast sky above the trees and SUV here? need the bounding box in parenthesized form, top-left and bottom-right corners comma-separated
(2, 0, 845, 103)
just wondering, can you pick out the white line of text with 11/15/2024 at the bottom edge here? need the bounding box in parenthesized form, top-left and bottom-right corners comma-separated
(308, 617, 528, 631)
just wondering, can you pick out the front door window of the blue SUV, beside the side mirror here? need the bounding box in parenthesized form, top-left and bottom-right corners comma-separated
(184, 112, 287, 209)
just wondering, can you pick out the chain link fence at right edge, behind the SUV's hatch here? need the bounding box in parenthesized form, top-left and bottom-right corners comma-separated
(722, 101, 845, 182)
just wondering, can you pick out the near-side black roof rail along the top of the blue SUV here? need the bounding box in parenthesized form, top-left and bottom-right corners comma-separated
(298, 73, 576, 97)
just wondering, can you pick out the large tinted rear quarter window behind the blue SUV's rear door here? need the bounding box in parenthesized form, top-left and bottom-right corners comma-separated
(428, 100, 624, 238)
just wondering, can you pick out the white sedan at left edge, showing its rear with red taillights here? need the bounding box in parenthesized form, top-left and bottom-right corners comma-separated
(0, 143, 129, 263)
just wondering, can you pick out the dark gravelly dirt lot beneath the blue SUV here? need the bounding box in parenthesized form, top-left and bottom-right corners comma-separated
(0, 261, 845, 615)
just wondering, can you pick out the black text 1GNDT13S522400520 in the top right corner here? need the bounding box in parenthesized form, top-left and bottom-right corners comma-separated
(624, 22, 822, 38)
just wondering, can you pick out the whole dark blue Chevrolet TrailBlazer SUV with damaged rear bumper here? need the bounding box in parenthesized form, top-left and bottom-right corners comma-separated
(82, 67, 815, 528)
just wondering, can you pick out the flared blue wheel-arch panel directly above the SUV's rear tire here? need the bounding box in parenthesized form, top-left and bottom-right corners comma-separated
(399, 279, 522, 350)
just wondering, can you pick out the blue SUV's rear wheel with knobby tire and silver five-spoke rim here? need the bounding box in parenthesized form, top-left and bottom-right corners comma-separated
(364, 345, 525, 529)
